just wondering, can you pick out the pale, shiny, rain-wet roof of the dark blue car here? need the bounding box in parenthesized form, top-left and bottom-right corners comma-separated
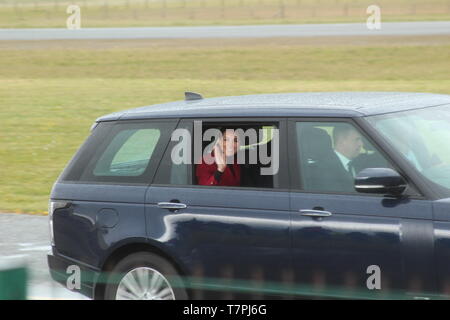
(97, 92, 450, 121)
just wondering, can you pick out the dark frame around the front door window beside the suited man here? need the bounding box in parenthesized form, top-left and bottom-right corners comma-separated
(288, 117, 427, 199)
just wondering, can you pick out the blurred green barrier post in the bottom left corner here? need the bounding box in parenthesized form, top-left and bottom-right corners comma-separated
(0, 258, 28, 300)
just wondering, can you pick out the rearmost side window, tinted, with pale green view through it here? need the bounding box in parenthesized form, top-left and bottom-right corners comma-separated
(63, 120, 176, 184)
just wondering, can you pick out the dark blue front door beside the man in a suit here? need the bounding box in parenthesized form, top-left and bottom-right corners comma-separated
(289, 119, 436, 298)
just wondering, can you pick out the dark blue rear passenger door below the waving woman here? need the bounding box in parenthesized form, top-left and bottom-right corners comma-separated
(145, 119, 291, 297)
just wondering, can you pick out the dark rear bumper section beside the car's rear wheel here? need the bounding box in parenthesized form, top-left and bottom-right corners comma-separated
(47, 254, 100, 299)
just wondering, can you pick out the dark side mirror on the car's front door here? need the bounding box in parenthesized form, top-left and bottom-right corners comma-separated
(355, 168, 408, 196)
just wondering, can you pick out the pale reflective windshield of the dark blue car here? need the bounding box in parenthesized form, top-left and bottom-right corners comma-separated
(367, 105, 450, 193)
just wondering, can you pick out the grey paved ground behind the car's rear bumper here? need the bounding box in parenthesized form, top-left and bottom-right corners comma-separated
(0, 213, 87, 299)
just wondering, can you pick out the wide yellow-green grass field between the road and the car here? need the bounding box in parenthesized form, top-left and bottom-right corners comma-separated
(0, 37, 450, 213)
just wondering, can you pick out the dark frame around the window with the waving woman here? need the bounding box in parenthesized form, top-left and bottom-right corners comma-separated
(151, 117, 289, 192)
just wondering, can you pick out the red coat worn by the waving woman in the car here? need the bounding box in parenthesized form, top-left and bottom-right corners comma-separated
(195, 154, 241, 187)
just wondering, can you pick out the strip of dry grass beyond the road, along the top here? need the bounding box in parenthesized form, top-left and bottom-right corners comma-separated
(0, 0, 450, 28)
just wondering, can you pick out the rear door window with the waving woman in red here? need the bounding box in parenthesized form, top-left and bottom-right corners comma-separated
(153, 120, 281, 188)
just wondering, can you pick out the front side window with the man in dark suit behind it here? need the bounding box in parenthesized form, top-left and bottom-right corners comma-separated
(295, 122, 392, 193)
